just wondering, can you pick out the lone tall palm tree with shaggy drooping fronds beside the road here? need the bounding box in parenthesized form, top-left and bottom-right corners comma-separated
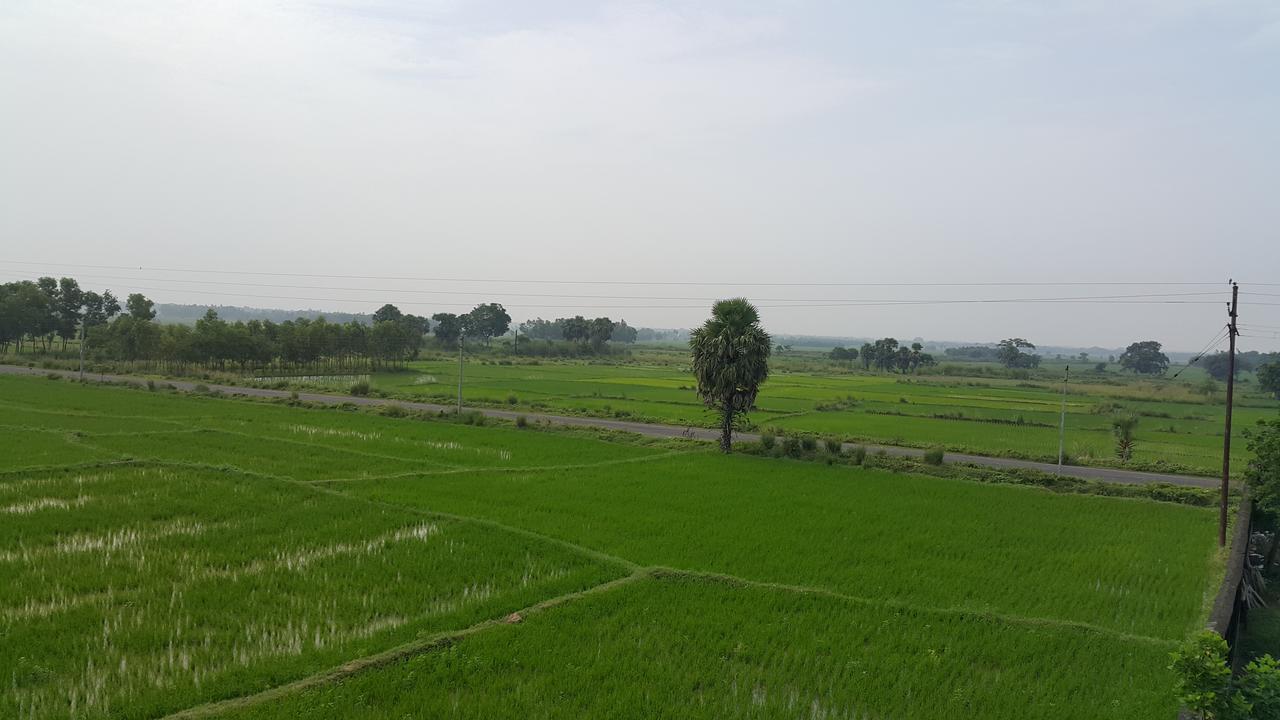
(689, 297, 772, 452)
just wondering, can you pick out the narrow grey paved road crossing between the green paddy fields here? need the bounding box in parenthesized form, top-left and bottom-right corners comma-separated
(0, 365, 1219, 488)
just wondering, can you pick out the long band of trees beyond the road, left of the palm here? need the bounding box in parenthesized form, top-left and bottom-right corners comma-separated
(0, 277, 653, 370)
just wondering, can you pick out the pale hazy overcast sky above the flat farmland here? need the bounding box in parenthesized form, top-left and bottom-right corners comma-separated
(0, 0, 1280, 350)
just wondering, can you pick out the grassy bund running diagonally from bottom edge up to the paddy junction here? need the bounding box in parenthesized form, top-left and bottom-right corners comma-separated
(163, 569, 652, 720)
